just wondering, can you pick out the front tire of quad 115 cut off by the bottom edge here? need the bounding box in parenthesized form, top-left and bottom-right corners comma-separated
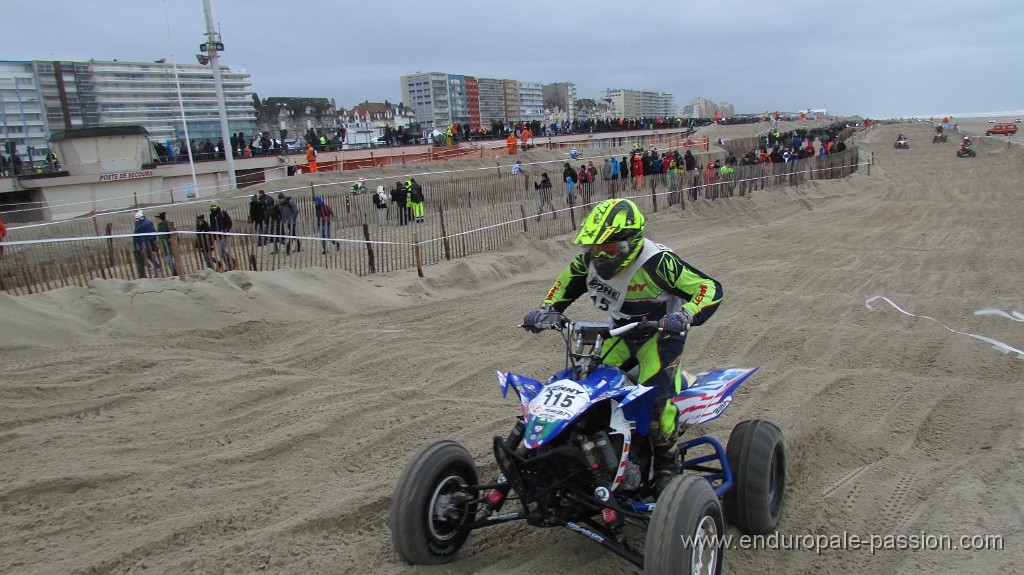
(643, 474, 725, 575)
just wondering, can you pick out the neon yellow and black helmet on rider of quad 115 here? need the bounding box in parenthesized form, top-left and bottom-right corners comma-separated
(572, 198, 644, 279)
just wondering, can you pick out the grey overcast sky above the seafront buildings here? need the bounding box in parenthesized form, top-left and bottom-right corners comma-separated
(0, 0, 1024, 118)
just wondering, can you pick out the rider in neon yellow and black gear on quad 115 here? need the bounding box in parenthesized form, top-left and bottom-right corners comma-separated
(523, 198, 722, 494)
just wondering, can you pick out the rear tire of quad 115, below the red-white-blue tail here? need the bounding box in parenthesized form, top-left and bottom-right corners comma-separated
(722, 419, 786, 535)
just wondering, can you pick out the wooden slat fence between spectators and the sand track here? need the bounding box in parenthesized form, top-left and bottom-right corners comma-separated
(0, 146, 859, 295)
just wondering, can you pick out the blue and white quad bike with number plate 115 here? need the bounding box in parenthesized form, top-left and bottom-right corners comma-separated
(389, 316, 786, 575)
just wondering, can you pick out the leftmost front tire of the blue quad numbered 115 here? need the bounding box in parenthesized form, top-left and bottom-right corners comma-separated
(388, 441, 479, 565)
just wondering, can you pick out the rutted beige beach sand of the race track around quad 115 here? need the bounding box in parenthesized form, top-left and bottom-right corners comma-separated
(0, 118, 1024, 575)
